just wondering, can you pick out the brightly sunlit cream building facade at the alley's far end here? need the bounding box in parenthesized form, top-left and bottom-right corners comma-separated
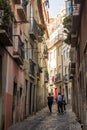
(48, 8, 65, 97)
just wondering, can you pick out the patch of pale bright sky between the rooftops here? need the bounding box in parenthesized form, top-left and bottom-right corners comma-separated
(49, 0, 65, 17)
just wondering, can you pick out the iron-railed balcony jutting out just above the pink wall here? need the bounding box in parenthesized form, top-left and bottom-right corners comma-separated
(13, 35, 24, 65)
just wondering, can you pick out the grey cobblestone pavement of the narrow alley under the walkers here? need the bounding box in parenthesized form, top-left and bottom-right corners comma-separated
(8, 105, 81, 130)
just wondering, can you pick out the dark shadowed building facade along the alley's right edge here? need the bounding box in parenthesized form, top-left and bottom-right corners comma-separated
(70, 0, 87, 130)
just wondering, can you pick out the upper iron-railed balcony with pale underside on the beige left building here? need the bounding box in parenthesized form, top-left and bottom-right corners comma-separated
(30, 18, 38, 40)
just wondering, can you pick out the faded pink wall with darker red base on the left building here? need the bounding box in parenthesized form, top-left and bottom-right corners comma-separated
(5, 57, 24, 130)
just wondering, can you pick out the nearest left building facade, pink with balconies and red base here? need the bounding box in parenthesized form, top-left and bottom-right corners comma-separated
(0, 1, 26, 130)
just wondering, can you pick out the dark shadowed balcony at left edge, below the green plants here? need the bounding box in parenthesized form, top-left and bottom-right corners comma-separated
(0, 25, 13, 47)
